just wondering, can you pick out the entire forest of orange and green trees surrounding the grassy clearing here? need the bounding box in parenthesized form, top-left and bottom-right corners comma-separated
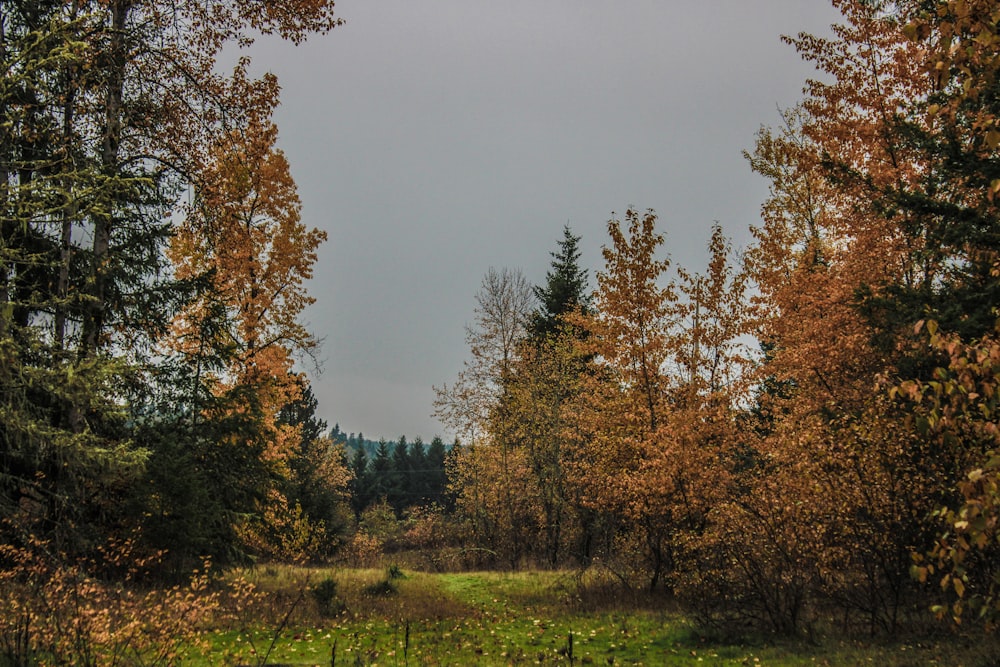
(0, 0, 1000, 665)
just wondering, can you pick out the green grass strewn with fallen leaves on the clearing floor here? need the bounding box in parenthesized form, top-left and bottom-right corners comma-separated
(178, 567, 1000, 667)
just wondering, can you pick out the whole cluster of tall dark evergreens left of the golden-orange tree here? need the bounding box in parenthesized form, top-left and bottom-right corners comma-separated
(0, 0, 338, 563)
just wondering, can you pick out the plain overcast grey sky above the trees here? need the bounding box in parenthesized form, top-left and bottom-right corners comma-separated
(242, 0, 837, 442)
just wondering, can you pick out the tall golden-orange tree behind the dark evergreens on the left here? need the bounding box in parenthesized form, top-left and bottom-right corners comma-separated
(170, 118, 347, 558)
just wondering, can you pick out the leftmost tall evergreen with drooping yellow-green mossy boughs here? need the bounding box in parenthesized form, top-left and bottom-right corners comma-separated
(0, 1, 176, 555)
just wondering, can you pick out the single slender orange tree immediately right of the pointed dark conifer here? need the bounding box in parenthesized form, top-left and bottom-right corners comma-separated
(570, 208, 676, 588)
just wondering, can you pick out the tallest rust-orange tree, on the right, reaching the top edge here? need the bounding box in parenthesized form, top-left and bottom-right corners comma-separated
(708, 0, 995, 632)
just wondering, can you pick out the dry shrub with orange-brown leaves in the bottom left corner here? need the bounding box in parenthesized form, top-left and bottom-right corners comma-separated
(0, 540, 219, 665)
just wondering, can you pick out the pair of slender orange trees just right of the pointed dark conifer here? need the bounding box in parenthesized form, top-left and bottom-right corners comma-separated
(570, 209, 744, 589)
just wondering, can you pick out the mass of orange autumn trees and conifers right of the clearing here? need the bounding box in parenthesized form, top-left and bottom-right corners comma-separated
(428, 0, 1000, 634)
